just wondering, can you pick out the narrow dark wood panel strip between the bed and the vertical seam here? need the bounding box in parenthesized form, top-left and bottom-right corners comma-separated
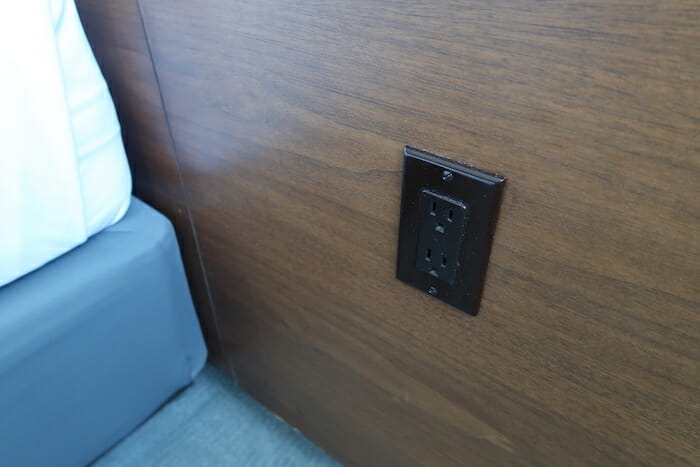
(76, 0, 224, 366)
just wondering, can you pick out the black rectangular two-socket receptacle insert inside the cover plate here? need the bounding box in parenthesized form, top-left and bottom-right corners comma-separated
(416, 189, 468, 285)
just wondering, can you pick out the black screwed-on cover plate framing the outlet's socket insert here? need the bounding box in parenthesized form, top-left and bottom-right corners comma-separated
(396, 146, 505, 315)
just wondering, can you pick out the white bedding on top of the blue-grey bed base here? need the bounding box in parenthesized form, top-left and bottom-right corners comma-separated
(0, 0, 131, 286)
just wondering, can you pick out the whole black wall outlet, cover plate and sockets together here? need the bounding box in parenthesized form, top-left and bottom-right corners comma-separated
(396, 146, 505, 315)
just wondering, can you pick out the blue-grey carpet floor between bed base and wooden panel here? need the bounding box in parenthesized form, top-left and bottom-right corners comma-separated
(93, 366, 340, 467)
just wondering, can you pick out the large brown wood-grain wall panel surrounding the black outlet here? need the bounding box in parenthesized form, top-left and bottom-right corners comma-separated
(140, 0, 700, 466)
